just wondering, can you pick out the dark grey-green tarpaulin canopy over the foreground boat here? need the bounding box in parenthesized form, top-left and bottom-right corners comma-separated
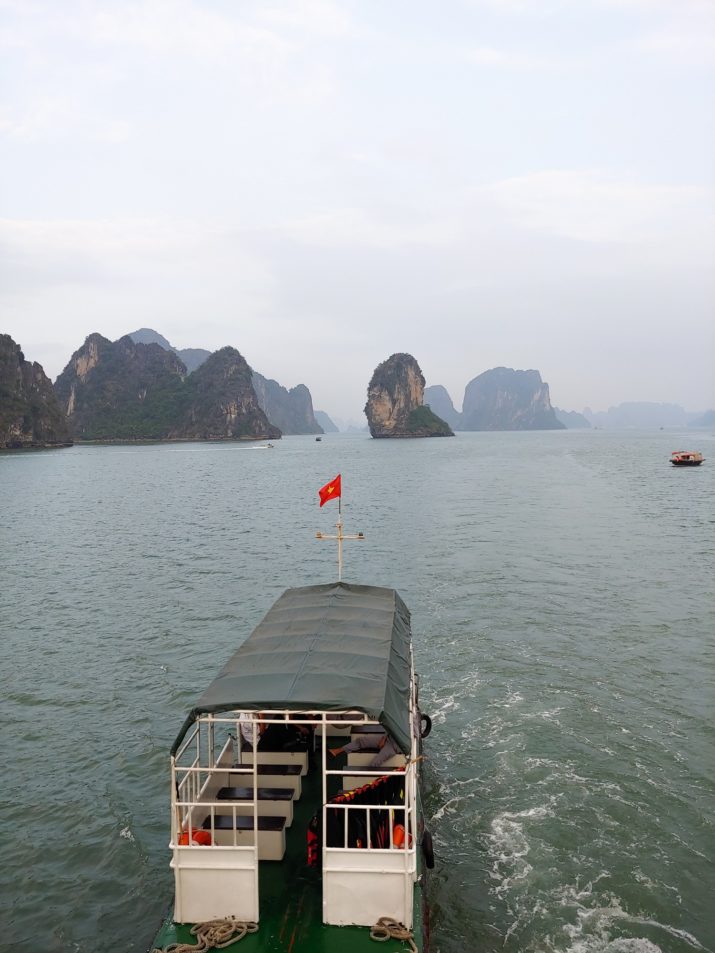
(172, 582, 411, 754)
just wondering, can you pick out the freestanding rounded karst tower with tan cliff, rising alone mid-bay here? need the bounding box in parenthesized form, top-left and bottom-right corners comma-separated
(365, 354, 454, 437)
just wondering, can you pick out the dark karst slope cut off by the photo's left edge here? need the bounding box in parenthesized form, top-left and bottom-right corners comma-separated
(0, 334, 72, 450)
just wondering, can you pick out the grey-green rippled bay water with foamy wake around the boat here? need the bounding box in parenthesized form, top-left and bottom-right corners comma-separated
(0, 431, 715, 953)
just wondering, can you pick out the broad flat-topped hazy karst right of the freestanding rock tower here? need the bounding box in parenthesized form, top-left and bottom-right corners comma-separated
(462, 367, 565, 430)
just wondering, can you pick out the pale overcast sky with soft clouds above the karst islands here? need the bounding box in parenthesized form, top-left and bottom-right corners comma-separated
(0, 0, 715, 420)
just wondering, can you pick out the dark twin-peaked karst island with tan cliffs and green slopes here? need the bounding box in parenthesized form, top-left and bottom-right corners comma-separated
(55, 334, 280, 440)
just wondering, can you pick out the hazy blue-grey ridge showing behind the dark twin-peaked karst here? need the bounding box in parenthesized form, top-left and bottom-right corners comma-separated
(129, 328, 323, 434)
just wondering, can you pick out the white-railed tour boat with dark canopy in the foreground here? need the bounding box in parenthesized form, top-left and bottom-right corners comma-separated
(152, 580, 434, 953)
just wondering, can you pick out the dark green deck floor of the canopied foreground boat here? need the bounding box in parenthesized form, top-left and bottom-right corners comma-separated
(148, 738, 423, 953)
